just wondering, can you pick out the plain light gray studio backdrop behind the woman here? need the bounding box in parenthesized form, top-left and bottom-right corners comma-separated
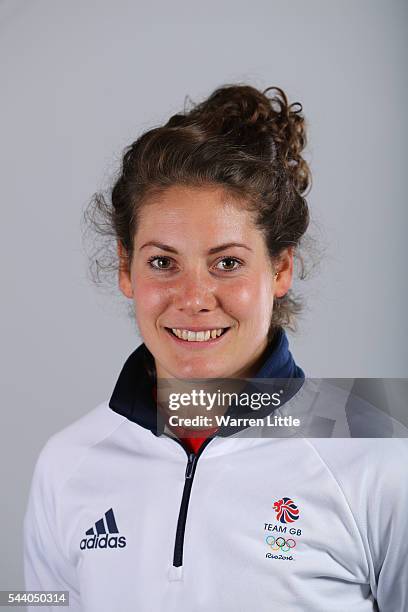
(0, 0, 408, 609)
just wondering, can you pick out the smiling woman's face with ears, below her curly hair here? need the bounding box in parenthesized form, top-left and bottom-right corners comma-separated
(118, 186, 293, 378)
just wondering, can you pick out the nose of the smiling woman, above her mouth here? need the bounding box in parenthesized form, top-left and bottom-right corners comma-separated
(173, 270, 217, 315)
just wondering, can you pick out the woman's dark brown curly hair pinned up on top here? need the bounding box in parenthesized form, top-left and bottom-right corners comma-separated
(85, 84, 311, 339)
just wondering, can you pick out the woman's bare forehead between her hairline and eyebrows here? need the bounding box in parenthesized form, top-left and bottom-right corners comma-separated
(135, 186, 260, 243)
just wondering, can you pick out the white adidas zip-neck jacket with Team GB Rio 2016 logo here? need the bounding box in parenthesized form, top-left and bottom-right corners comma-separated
(24, 342, 408, 612)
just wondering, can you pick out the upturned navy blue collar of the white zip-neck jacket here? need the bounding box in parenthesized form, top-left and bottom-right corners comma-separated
(109, 328, 305, 436)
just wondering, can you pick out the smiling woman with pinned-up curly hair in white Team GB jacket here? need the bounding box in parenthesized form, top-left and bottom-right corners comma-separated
(25, 85, 408, 612)
